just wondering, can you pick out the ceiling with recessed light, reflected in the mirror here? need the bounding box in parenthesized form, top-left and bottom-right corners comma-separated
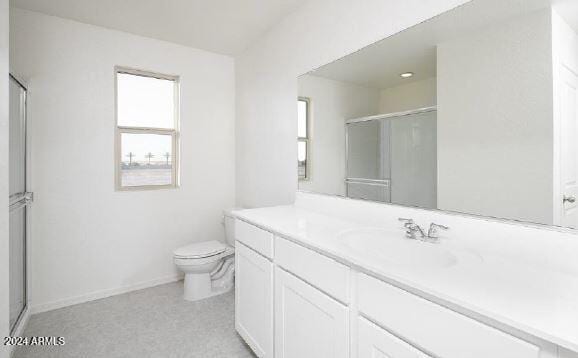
(310, 0, 552, 89)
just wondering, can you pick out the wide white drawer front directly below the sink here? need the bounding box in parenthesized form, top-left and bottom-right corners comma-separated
(358, 274, 540, 358)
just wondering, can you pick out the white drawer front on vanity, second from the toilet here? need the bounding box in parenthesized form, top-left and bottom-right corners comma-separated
(275, 237, 349, 304)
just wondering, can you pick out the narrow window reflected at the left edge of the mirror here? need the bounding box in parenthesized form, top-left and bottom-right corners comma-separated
(297, 97, 311, 180)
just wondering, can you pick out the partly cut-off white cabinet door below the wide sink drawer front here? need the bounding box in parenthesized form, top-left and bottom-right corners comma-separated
(357, 317, 427, 358)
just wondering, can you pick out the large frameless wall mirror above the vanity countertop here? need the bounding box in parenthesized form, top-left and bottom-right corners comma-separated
(297, 0, 578, 228)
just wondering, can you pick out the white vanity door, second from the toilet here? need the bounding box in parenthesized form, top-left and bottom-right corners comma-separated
(275, 267, 349, 358)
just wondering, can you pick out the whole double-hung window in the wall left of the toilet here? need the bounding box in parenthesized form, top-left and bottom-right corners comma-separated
(115, 68, 179, 190)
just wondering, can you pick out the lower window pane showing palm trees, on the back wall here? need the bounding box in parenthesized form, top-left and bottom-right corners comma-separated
(121, 133, 173, 187)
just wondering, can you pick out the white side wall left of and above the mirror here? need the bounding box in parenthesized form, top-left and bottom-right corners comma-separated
(236, 0, 467, 207)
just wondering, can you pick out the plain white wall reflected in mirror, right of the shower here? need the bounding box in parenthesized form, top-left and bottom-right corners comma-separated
(437, 10, 553, 224)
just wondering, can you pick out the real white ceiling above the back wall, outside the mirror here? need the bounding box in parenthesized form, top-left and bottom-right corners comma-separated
(10, 0, 307, 55)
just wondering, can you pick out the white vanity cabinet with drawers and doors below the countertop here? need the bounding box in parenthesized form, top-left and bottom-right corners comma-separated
(235, 220, 578, 358)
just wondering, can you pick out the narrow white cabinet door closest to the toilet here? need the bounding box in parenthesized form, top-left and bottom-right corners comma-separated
(235, 241, 273, 358)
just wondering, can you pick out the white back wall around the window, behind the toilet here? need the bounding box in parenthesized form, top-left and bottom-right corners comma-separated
(9, 9, 234, 310)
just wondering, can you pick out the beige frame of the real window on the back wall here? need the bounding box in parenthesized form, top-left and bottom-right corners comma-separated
(114, 66, 180, 191)
